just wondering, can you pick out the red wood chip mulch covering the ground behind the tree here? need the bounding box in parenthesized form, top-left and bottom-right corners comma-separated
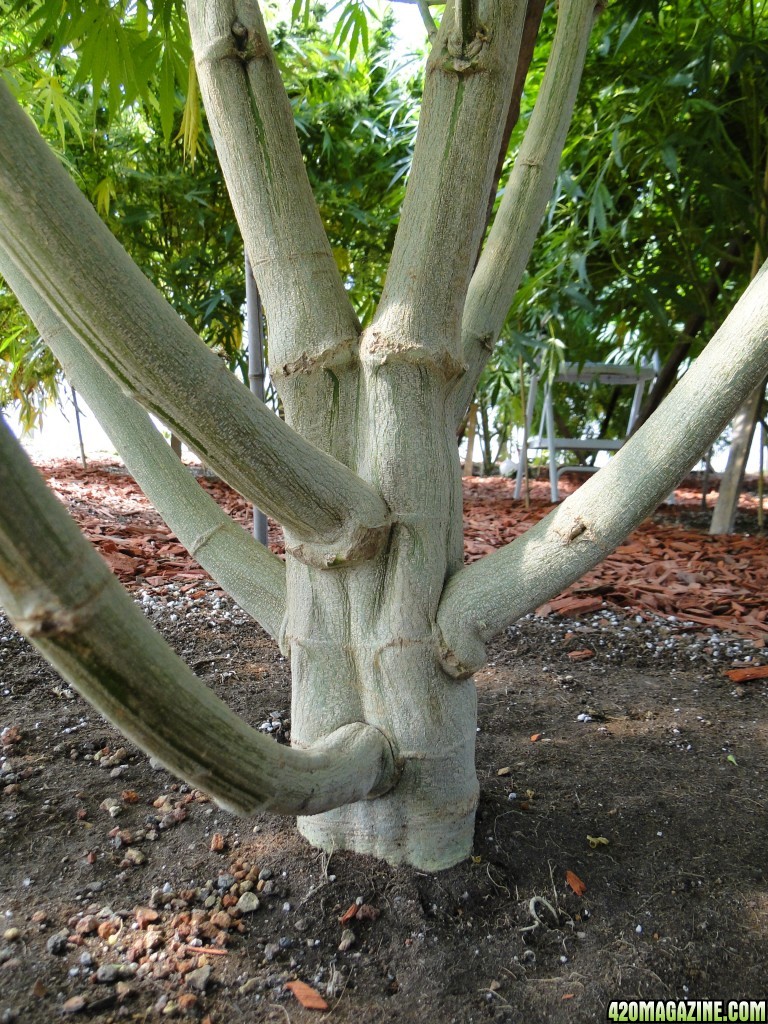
(33, 462, 768, 647)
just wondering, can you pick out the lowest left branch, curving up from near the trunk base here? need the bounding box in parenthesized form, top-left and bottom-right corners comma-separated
(0, 423, 396, 814)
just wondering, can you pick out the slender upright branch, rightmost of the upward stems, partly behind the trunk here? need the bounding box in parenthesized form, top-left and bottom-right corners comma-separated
(455, 0, 596, 422)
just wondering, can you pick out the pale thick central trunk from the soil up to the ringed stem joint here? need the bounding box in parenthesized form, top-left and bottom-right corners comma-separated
(284, 364, 478, 870)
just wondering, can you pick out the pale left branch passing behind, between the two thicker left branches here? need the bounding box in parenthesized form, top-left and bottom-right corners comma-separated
(0, 249, 286, 639)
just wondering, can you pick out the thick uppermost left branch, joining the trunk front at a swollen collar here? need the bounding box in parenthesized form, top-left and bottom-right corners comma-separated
(0, 85, 388, 565)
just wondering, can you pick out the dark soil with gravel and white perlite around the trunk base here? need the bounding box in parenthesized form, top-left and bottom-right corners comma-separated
(0, 460, 768, 1024)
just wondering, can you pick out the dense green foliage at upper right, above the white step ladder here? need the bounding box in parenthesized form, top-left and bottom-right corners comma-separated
(487, 0, 768, 452)
